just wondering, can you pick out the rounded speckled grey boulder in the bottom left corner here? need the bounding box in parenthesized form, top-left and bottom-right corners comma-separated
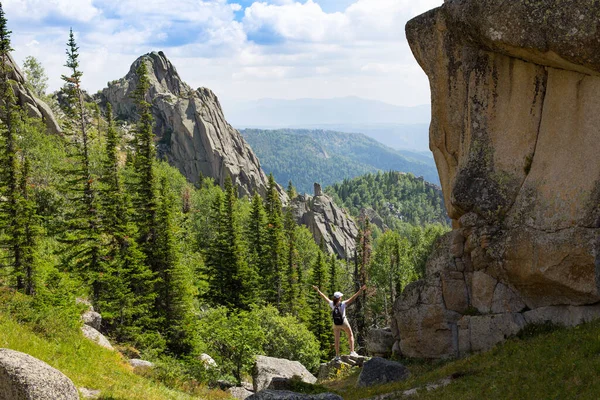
(0, 349, 79, 400)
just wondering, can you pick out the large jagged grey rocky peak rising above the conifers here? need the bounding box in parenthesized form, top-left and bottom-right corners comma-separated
(100, 52, 278, 198)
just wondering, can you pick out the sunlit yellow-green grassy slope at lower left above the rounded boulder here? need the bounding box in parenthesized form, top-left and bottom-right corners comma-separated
(0, 292, 230, 400)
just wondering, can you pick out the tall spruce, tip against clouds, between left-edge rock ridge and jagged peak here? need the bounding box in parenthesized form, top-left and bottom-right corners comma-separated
(61, 29, 104, 302)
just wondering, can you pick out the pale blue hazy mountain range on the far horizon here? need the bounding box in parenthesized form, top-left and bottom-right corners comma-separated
(224, 97, 431, 151)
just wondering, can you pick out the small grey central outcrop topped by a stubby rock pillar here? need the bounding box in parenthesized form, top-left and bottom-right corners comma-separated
(291, 183, 358, 259)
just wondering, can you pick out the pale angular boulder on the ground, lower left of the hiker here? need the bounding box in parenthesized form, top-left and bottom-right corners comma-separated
(252, 356, 317, 392)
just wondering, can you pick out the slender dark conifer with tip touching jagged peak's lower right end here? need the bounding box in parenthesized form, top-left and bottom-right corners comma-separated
(261, 174, 286, 312)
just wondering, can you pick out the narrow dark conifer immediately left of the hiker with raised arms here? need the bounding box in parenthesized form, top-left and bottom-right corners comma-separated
(309, 251, 333, 360)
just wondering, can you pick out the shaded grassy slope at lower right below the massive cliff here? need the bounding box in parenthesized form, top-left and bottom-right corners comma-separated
(326, 321, 600, 400)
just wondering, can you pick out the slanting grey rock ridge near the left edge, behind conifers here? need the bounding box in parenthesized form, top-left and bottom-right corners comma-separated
(8, 55, 62, 134)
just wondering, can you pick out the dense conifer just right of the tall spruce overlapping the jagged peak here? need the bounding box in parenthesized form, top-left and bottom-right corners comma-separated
(154, 178, 195, 355)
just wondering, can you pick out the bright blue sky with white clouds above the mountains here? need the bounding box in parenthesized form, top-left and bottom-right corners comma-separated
(2, 0, 443, 106)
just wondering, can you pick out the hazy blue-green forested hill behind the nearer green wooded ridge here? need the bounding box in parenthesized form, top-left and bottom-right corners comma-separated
(241, 129, 439, 193)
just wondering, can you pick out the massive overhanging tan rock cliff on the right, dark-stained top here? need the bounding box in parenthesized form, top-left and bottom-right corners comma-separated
(392, 0, 600, 357)
